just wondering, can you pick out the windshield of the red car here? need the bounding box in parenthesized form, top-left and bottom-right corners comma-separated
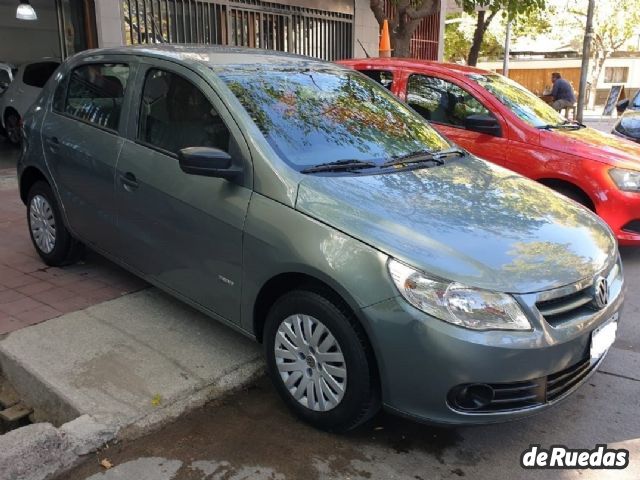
(469, 74, 566, 127)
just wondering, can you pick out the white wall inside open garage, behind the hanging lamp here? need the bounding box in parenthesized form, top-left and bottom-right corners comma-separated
(0, 0, 60, 65)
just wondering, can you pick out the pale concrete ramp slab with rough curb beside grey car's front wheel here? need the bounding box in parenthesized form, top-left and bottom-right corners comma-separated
(0, 289, 264, 480)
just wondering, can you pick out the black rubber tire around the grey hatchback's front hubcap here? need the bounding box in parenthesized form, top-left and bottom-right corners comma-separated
(263, 290, 380, 432)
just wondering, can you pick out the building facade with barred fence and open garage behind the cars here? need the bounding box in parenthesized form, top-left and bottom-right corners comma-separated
(0, 0, 444, 64)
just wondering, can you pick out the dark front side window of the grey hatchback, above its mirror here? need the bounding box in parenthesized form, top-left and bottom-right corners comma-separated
(138, 69, 230, 154)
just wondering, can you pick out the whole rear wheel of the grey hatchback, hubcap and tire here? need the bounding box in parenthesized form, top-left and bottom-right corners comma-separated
(27, 181, 81, 267)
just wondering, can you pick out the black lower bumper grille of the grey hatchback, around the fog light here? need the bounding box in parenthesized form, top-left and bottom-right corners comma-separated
(448, 359, 599, 413)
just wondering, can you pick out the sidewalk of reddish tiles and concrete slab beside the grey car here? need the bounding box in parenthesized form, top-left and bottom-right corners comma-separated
(0, 176, 263, 480)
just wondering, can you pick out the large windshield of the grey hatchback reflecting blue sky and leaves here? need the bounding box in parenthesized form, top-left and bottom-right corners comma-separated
(220, 68, 451, 170)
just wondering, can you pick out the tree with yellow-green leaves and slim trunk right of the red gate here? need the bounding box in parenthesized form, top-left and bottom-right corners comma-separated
(456, 0, 545, 65)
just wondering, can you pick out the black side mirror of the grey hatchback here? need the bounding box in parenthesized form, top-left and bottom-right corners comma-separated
(178, 147, 242, 180)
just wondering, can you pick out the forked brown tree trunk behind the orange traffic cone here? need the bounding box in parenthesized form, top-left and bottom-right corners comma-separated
(370, 0, 440, 57)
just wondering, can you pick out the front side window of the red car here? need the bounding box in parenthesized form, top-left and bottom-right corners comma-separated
(407, 75, 491, 127)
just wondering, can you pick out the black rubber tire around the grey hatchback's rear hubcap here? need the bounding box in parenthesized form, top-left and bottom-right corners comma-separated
(27, 181, 82, 267)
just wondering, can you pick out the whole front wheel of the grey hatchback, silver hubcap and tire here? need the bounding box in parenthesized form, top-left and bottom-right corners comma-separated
(264, 290, 379, 431)
